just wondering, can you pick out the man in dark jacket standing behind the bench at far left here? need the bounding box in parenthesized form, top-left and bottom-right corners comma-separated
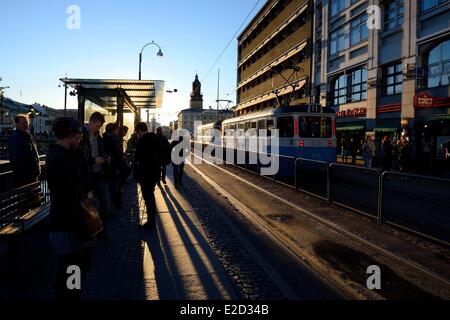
(8, 114, 41, 188)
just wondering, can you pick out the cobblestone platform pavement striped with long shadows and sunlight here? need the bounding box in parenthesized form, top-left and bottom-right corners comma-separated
(0, 168, 292, 300)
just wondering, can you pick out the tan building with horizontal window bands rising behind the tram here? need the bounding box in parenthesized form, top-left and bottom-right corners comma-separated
(236, 0, 313, 115)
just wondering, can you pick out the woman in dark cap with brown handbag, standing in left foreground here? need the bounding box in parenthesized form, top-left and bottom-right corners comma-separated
(46, 117, 98, 300)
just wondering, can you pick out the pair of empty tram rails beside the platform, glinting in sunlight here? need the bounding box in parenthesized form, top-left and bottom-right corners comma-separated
(189, 155, 450, 299)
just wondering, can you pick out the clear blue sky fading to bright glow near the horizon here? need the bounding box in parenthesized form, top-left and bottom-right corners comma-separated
(0, 0, 265, 124)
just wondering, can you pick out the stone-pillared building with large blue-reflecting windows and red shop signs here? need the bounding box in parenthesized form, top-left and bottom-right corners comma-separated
(312, 0, 450, 172)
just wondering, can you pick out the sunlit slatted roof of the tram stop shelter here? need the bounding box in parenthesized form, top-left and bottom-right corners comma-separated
(60, 78, 164, 127)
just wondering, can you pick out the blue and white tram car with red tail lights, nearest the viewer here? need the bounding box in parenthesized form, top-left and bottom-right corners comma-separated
(222, 104, 336, 163)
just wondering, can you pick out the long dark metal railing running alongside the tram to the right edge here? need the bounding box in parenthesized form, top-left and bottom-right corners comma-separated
(198, 142, 450, 245)
